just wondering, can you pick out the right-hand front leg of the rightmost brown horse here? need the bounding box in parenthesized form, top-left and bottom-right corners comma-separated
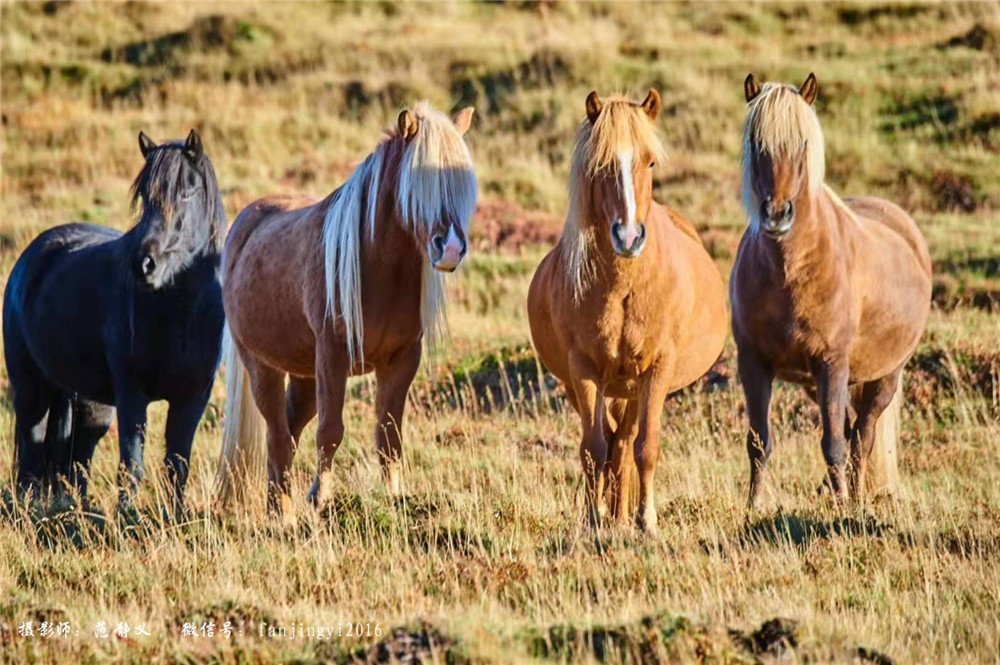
(813, 361, 849, 502)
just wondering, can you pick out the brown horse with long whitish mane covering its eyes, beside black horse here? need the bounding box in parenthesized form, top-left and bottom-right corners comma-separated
(219, 103, 477, 509)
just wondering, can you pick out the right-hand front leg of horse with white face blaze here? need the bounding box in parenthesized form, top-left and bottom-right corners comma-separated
(633, 359, 673, 536)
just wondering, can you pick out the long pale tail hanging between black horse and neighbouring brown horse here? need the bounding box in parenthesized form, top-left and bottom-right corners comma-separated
(216, 323, 267, 506)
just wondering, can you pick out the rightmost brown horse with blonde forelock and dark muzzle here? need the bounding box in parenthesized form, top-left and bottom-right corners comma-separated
(729, 74, 931, 508)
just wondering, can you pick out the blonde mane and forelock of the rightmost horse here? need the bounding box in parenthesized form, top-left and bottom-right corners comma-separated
(742, 83, 835, 230)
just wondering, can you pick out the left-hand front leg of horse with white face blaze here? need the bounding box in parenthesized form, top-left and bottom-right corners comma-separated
(569, 352, 608, 529)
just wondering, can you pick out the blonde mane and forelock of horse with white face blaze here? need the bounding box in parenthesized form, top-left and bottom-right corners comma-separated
(559, 95, 666, 301)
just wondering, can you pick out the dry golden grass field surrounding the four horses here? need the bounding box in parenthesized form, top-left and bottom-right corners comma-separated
(0, 0, 1000, 663)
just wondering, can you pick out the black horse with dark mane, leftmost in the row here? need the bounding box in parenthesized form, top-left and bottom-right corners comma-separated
(3, 130, 226, 511)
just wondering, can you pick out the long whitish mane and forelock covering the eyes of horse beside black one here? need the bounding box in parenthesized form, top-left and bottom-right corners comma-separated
(323, 102, 477, 366)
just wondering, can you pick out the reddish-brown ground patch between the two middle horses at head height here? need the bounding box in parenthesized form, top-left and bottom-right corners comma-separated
(472, 199, 563, 250)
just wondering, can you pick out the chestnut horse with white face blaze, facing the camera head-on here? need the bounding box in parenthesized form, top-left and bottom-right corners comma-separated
(528, 90, 728, 532)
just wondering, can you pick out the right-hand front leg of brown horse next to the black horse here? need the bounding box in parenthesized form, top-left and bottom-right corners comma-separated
(375, 344, 421, 496)
